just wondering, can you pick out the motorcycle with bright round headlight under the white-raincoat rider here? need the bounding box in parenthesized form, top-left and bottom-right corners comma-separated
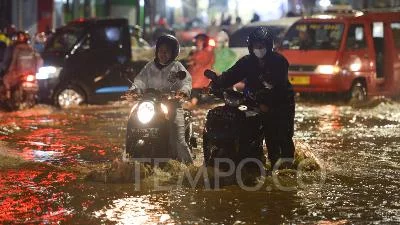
(123, 67, 197, 162)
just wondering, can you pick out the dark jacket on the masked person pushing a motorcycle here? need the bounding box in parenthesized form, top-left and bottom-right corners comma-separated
(212, 52, 294, 107)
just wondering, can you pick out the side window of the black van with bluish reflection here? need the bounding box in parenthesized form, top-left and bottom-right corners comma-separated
(93, 26, 122, 48)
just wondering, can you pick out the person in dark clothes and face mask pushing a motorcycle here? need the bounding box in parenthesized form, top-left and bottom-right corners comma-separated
(212, 27, 295, 169)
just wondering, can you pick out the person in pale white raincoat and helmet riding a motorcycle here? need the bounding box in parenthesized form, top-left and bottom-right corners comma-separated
(131, 35, 193, 163)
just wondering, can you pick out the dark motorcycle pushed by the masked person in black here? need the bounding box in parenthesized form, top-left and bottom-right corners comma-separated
(203, 70, 266, 168)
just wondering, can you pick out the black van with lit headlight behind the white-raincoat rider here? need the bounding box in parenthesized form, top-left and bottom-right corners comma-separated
(36, 19, 132, 107)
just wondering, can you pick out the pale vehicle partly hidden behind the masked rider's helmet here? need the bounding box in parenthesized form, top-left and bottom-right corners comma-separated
(229, 17, 301, 58)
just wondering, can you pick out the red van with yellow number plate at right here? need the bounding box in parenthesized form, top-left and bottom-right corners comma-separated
(279, 11, 400, 101)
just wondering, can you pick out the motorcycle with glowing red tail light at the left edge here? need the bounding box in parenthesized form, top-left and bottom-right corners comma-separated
(0, 73, 39, 111)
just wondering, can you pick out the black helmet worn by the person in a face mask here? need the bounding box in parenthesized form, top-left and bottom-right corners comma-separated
(247, 27, 274, 54)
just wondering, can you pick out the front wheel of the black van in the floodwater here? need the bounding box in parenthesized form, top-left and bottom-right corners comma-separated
(54, 85, 86, 109)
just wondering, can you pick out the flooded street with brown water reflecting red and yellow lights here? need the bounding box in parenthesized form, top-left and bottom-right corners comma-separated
(0, 101, 400, 224)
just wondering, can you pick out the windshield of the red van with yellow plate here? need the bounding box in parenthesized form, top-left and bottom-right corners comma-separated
(282, 23, 344, 50)
